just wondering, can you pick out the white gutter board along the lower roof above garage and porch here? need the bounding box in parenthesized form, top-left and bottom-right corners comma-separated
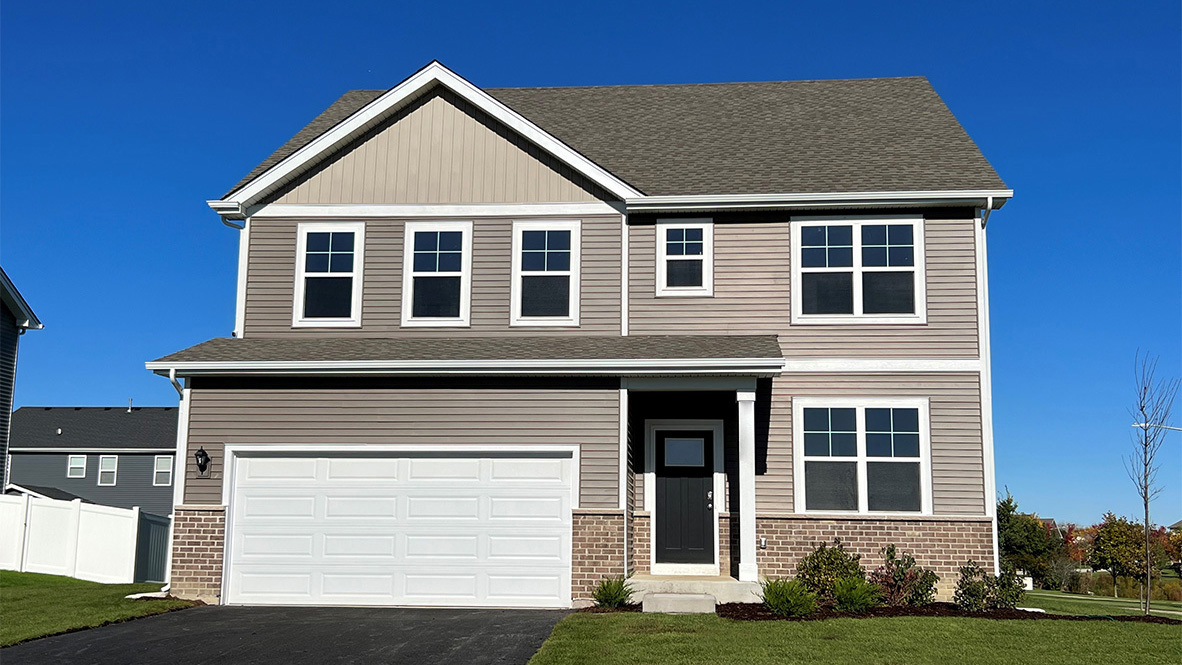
(145, 358, 784, 376)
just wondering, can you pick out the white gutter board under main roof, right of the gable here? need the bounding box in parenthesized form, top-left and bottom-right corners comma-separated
(624, 189, 1014, 213)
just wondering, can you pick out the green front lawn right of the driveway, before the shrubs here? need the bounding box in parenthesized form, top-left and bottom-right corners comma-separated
(530, 613, 1182, 665)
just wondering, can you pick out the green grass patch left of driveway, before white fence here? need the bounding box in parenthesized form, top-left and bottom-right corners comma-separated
(0, 571, 193, 646)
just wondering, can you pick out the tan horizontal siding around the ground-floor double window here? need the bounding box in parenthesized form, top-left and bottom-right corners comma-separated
(755, 373, 986, 515)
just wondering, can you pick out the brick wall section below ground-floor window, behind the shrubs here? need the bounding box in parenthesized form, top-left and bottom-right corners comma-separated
(755, 517, 993, 599)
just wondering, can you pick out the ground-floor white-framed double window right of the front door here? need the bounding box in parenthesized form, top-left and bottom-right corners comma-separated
(793, 397, 931, 514)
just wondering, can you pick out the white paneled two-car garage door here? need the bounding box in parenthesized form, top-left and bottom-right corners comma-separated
(226, 452, 574, 607)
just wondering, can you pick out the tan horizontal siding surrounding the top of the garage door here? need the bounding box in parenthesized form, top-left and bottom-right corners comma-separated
(184, 385, 619, 509)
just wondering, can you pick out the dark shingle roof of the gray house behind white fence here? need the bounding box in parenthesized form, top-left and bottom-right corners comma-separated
(8, 406, 176, 449)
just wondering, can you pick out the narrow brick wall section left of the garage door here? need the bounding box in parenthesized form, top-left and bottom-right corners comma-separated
(170, 506, 226, 604)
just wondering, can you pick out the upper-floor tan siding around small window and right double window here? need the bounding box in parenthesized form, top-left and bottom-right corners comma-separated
(628, 219, 979, 358)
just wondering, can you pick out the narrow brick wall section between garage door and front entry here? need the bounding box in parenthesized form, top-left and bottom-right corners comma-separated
(571, 510, 625, 601)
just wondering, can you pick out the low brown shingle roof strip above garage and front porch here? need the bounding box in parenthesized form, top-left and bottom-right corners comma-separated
(154, 335, 782, 363)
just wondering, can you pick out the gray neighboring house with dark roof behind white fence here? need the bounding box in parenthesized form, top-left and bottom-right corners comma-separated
(7, 406, 177, 517)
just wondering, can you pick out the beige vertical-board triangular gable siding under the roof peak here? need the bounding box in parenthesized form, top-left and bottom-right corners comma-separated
(268, 91, 599, 203)
